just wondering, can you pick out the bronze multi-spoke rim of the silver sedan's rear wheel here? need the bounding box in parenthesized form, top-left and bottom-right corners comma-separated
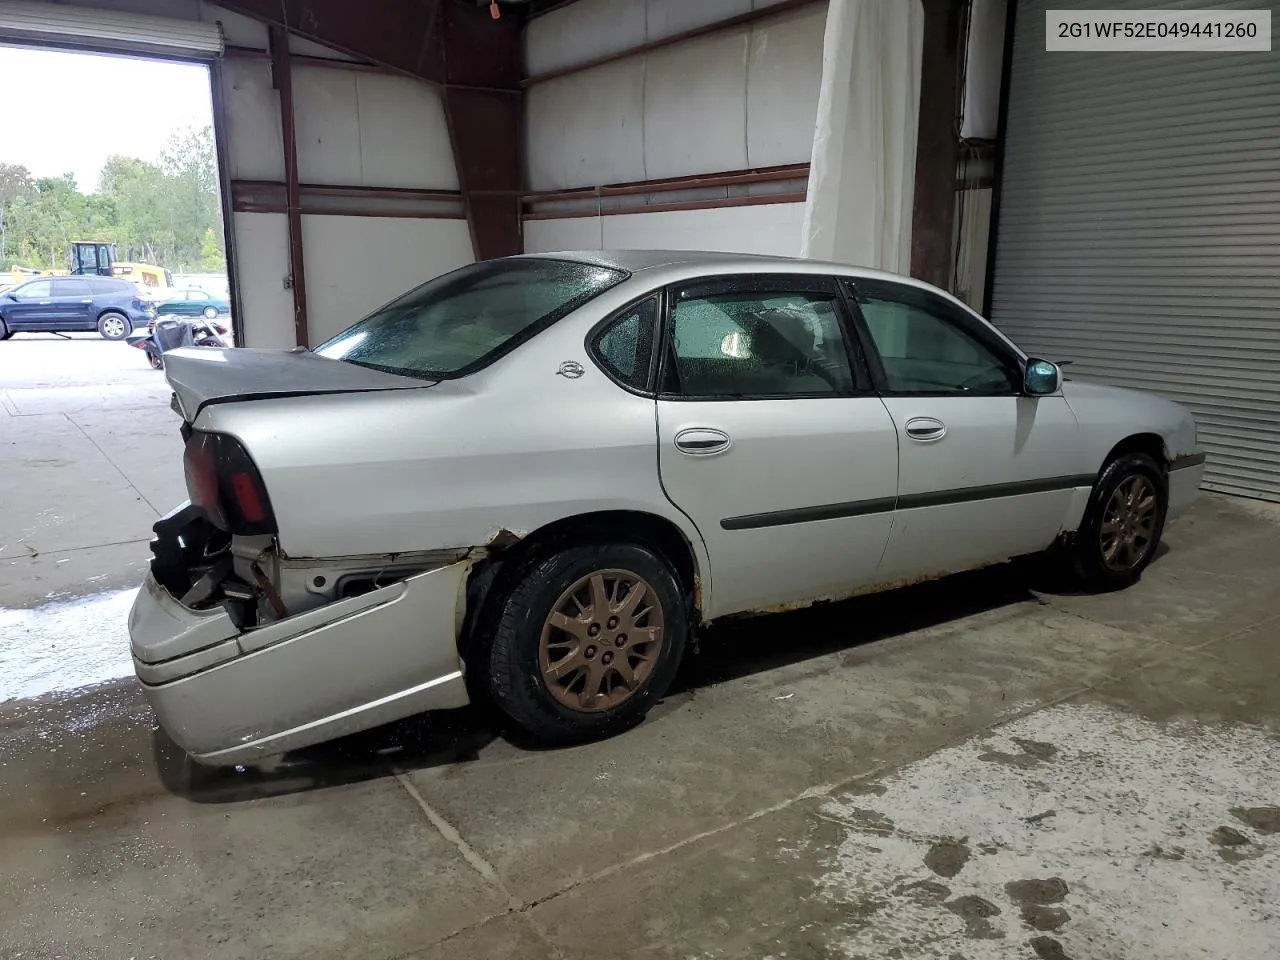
(538, 570, 663, 712)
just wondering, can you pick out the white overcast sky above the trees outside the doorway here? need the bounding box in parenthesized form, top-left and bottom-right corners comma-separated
(0, 46, 212, 193)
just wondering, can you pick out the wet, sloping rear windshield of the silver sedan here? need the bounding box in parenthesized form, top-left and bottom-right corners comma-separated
(315, 259, 627, 380)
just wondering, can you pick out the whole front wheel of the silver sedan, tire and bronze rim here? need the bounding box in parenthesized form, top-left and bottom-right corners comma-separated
(1074, 453, 1169, 590)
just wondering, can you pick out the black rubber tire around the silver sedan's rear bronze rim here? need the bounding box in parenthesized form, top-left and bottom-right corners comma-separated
(488, 543, 689, 745)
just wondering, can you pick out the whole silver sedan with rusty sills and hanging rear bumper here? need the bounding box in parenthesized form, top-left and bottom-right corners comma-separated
(129, 251, 1204, 764)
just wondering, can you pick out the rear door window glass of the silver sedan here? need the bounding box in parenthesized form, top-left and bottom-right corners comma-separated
(663, 285, 854, 398)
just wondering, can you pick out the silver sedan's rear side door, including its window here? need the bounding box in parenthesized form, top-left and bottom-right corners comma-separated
(657, 275, 897, 617)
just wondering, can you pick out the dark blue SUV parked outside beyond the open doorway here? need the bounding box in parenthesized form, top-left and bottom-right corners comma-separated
(0, 276, 155, 340)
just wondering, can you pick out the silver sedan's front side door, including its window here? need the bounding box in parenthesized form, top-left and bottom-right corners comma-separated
(847, 273, 1093, 581)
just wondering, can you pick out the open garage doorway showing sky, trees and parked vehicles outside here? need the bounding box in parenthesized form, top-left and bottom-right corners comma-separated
(0, 45, 233, 399)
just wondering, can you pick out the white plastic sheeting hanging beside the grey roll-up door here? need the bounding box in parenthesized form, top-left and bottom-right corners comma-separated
(801, 0, 924, 274)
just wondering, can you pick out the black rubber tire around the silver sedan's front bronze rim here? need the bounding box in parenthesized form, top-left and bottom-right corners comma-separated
(1071, 453, 1169, 591)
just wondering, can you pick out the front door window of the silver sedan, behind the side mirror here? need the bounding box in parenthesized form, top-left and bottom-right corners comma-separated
(854, 280, 1019, 396)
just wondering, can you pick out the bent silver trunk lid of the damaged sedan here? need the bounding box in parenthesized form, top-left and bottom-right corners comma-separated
(164, 347, 435, 422)
